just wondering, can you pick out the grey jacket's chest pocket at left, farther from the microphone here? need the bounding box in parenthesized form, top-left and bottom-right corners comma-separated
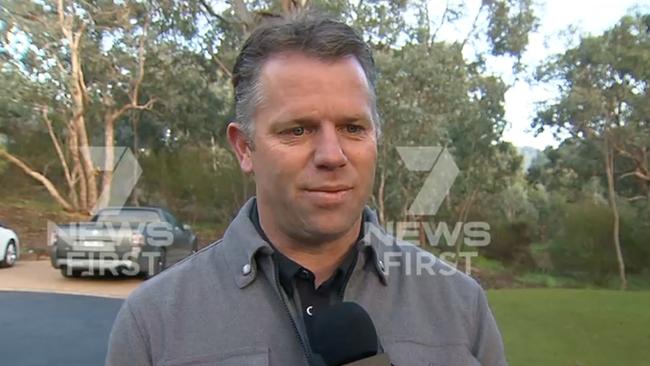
(162, 347, 269, 366)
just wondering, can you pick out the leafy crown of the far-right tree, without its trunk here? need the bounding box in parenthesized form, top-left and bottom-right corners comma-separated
(533, 14, 650, 197)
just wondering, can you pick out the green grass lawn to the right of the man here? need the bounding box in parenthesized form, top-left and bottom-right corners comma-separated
(488, 289, 650, 366)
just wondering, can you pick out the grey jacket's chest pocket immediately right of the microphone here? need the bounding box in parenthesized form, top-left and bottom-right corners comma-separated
(384, 340, 481, 366)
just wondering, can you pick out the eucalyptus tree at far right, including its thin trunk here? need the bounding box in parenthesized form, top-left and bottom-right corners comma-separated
(533, 14, 650, 289)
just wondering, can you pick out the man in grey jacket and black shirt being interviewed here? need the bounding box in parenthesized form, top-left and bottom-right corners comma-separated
(107, 12, 505, 366)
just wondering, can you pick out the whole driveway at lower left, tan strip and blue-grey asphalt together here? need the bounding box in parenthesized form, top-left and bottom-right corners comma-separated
(0, 261, 143, 366)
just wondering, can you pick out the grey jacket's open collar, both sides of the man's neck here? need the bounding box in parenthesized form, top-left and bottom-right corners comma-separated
(219, 197, 387, 288)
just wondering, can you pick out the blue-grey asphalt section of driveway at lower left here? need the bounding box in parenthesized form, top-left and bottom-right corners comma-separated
(0, 291, 122, 366)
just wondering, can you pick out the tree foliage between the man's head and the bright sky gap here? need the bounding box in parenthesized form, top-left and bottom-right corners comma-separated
(374, 35, 521, 221)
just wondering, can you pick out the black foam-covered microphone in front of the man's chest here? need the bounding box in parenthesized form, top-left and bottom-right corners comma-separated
(310, 302, 390, 366)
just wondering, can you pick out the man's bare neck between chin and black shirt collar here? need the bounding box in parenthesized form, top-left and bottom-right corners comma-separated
(260, 212, 362, 286)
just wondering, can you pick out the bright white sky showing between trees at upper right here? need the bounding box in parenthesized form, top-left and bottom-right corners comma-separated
(442, 0, 650, 150)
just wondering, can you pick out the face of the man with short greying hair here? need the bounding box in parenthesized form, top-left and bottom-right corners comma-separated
(230, 53, 377, 242)
